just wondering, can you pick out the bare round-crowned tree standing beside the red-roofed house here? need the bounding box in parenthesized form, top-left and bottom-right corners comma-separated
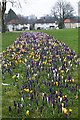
(51, 0, 74, 28)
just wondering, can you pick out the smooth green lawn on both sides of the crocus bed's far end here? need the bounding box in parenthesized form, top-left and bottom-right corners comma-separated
(2, 29, 78, 53)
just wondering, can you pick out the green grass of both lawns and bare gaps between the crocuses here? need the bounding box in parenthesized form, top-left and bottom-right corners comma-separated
(2, 29, 78, 118)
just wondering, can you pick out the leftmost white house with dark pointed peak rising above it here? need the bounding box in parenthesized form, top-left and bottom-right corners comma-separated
(5, 9, 30, 32)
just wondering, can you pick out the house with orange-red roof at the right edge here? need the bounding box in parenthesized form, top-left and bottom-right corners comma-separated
(64, 17, 80, 28)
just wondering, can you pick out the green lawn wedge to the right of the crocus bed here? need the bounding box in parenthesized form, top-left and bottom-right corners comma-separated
(36, 29, 78, 53)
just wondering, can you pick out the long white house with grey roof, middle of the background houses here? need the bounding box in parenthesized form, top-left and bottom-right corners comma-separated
(35, 18, 59, 30)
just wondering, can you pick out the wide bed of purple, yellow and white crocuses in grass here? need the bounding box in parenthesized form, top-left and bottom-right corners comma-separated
(1, 32, 78, 119)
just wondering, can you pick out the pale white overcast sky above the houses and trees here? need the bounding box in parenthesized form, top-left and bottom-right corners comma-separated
(6, 0, 79, 18)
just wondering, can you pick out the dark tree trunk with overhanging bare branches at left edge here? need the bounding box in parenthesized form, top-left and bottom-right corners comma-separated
(1, 0, 26, 32)
